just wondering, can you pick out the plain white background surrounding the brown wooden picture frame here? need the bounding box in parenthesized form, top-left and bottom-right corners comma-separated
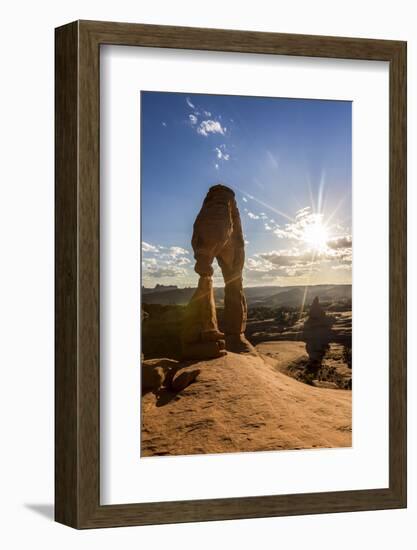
(0, 0, 417, 550)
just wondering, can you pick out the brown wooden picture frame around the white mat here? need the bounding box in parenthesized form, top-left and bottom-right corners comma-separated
(55, 21, 407, 528)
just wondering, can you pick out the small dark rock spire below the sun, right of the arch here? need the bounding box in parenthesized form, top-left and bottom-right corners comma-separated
(303, 296, 333, 368)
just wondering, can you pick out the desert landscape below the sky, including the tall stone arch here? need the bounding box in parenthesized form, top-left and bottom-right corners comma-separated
(141, 185, 352, 456)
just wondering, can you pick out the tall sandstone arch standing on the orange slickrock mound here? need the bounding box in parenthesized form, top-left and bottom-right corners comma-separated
(182, 185, 253, 359)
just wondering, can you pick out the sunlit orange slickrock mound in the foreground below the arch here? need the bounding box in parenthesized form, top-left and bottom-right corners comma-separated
(141, 350, 352, 456)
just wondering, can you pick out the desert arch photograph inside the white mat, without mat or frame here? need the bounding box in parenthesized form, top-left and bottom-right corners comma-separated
(138, 90, 353, 457)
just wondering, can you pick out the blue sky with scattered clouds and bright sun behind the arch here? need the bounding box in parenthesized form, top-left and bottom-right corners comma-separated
(141, 92, 352, 287)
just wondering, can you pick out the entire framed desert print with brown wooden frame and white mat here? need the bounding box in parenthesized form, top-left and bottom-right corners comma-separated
(55, 21, 406, 528)
